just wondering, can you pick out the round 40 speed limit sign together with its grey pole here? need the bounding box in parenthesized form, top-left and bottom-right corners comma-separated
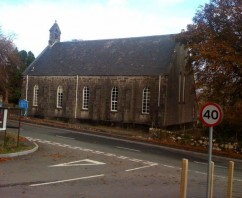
(200, 102, 223, 198)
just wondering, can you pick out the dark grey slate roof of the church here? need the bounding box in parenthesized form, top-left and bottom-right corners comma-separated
(23, 35, 176, 76)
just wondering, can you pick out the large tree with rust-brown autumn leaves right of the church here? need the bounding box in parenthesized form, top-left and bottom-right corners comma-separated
(176, 0, 242, 138)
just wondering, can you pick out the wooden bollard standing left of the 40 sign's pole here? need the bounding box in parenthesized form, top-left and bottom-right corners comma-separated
(180, 159, 188, 198)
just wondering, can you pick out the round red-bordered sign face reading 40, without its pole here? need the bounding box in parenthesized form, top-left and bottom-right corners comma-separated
(200, 102, 223, 127)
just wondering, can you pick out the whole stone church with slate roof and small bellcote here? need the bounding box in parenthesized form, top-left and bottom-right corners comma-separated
(22, 22, 196, 128)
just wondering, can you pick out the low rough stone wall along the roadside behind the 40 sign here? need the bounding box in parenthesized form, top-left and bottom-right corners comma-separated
(149, 128, 242, 154)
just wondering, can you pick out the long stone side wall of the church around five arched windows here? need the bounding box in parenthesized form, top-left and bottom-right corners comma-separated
(22, 76, 166, 126)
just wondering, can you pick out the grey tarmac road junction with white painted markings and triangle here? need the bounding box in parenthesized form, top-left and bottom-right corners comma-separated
(0, 121, 242, 198)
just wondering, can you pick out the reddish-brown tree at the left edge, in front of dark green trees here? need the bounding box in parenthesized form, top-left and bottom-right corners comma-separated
(0, 29, 20, 103)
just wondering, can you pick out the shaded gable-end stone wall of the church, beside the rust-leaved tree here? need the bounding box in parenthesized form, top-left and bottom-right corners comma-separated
(164, 44, 196, 126)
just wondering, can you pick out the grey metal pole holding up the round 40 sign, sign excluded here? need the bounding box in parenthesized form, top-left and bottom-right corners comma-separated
(207, 126, 213, 198)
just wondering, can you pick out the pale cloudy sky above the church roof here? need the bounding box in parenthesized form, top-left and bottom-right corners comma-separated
(0, 0, 209, 56)
